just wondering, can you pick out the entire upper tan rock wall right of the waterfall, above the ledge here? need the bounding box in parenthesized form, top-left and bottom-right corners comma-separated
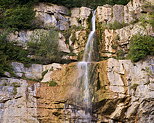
(96, 0, 154, 57)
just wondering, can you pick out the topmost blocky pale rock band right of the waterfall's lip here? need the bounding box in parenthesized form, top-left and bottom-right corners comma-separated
(96, 0, 145, 23)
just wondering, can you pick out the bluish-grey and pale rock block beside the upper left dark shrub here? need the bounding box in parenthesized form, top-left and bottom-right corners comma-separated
(34, 3, 69, 30)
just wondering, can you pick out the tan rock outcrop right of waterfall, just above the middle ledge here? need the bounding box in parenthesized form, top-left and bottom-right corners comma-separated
(99, 23, 154, 57)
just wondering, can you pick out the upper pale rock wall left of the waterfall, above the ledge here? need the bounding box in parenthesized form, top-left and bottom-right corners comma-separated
(8, 3, 92, 59)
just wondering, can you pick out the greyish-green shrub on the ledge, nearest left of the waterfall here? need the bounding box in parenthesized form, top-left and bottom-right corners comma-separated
(27, 30, 62, 64)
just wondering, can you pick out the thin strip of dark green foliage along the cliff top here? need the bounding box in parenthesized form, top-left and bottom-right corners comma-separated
(0, 0, 130, 8)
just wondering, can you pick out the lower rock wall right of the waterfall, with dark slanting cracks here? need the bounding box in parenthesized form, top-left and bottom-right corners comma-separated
(96, 57, 154, 123)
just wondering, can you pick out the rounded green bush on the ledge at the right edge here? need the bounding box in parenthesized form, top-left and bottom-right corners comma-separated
(129, 35, 154, 62)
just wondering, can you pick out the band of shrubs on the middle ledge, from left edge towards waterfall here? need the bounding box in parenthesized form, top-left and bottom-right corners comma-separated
(0, 30, 63, 76)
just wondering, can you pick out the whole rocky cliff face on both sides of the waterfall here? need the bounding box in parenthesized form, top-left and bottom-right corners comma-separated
(0, 0, 154, 123)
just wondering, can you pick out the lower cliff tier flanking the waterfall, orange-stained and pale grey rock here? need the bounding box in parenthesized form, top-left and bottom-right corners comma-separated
(0, 57, 154, 123)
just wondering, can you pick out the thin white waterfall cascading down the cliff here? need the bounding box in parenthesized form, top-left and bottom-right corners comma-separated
(78, 11, 96, 123)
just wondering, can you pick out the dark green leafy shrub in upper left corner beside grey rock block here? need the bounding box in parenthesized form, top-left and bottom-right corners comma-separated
(3, 6, 35, 29)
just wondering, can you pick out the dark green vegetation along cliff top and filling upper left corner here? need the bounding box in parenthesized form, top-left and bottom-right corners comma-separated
(0, 0, 130, 30)
